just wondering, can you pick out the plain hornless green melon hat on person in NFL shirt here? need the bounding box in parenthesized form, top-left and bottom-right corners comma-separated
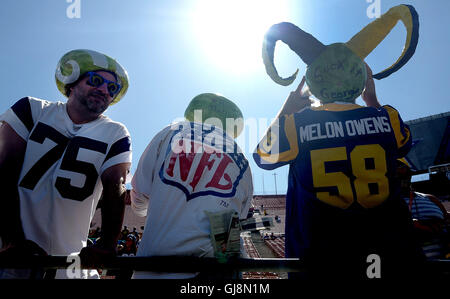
(184, 93, 244, 138)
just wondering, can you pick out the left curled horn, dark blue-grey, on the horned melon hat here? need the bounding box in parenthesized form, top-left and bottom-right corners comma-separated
(262, 22, 325, 86)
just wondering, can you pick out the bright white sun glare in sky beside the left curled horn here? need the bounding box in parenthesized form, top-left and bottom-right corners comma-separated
(193, 0, 288, 73)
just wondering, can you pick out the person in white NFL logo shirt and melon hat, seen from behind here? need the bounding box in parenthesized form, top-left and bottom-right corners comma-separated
(131, 94, 253, 278)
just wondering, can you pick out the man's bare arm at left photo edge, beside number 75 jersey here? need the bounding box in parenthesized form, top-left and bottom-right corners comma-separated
(0, 122, 26, 249)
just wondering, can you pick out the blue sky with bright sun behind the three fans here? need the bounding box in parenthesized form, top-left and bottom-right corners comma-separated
(0, 0, 450, 194)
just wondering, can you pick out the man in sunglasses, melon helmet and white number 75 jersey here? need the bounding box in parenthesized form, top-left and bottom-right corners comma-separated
(0, 50, 131, 278)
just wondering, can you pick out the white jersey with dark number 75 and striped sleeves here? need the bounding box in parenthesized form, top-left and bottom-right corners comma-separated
(0, 97, 131, 255)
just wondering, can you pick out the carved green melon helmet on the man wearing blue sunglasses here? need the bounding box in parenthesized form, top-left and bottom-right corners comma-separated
(55, 49, 128, 105)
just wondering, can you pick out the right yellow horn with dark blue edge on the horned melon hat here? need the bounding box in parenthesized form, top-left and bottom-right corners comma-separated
(346, 5, 419, 80)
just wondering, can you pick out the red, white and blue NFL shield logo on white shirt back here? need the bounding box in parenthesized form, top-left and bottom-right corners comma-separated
(159, 124, 248, 201)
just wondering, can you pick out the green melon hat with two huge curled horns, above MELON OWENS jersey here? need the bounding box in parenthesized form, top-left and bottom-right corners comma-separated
(262, 5, 419, 103)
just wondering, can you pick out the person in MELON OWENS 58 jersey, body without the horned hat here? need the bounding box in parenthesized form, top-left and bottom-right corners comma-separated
(254, 65, 423, 279)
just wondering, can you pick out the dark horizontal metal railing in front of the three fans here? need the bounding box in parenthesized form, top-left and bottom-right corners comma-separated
(0, 256, 450, 277)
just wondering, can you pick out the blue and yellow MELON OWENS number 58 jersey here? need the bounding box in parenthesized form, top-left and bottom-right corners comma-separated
(254, 103, 411, 256)
